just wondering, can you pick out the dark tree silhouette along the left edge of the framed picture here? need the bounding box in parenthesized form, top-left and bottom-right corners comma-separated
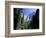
(13, 8, 22, 30)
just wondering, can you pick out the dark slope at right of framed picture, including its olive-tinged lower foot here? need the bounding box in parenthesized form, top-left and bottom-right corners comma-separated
(28, 9, 39, 29)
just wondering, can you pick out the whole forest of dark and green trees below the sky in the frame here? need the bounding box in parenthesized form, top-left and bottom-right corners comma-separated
(13, 8, 39, 30)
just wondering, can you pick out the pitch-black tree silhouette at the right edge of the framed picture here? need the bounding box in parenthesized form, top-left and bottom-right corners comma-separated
(32, 9, 39, 29)
